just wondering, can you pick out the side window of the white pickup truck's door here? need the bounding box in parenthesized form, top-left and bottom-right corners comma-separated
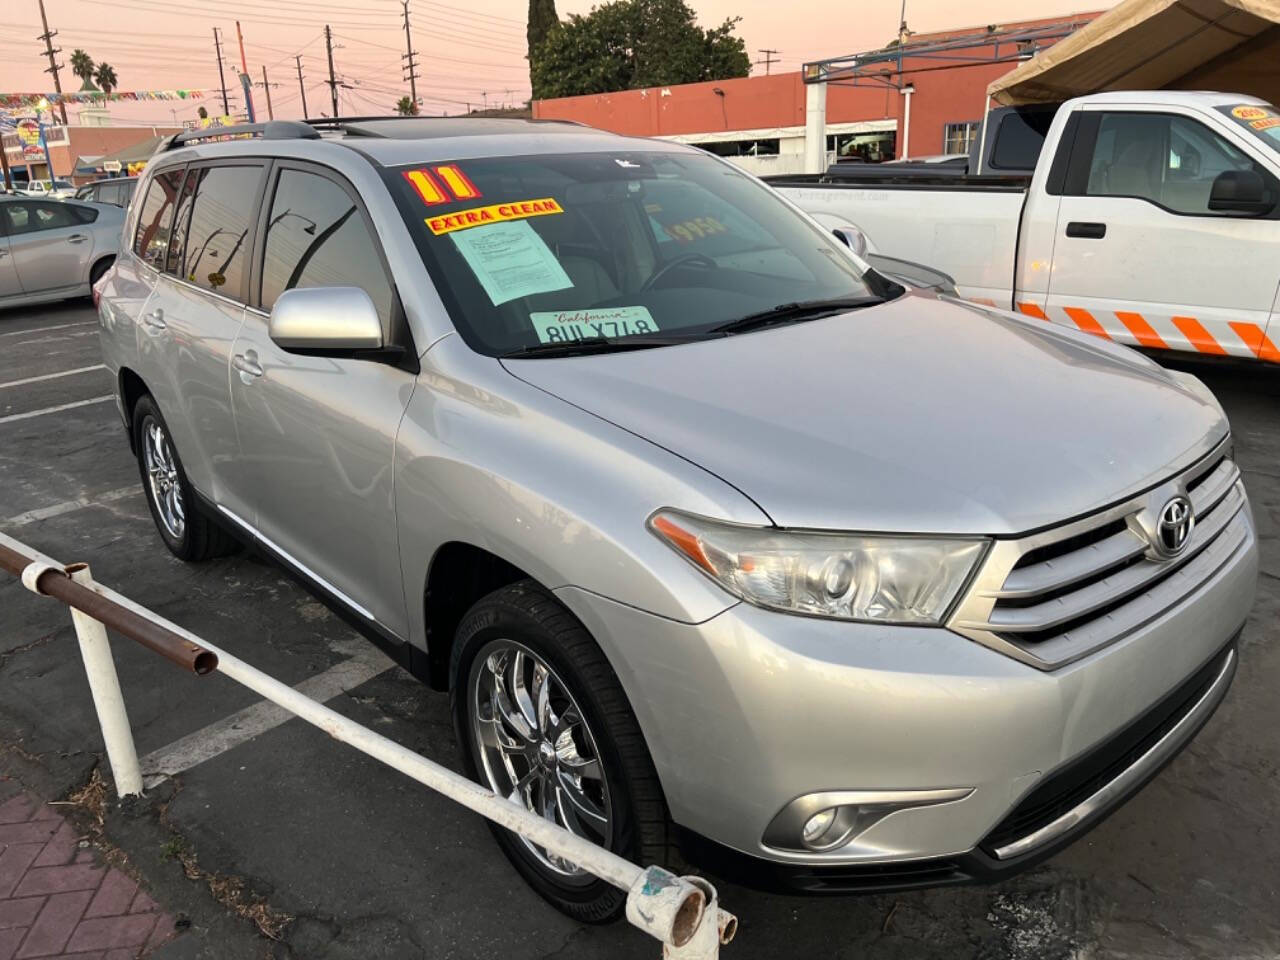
(1085, 113, 1280, 216)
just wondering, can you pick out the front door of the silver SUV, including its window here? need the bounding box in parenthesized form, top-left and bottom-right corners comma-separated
(230, 161, 417, 639)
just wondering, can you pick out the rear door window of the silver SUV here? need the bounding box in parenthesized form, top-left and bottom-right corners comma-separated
(180, 166, 262, 298)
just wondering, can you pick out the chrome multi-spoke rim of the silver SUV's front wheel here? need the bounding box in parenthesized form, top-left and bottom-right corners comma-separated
(471, 640, 613, 883)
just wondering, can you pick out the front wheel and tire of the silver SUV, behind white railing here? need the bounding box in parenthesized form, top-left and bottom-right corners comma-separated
(452, 580, 675, 923)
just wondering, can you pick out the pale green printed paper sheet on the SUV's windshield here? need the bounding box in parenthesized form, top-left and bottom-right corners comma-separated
(449, 220, 573, 306)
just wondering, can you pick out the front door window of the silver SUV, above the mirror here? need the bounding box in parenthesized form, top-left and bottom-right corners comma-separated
(262, 170, 393, 330)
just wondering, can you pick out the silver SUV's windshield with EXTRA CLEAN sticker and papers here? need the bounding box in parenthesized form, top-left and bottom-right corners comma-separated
(389, 152, 900, 356)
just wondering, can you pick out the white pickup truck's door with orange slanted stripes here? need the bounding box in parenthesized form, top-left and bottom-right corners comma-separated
(1039, 108, 1280, 360)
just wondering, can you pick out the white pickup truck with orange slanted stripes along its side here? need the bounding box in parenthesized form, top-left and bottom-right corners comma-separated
(769, 91, 1280, 362)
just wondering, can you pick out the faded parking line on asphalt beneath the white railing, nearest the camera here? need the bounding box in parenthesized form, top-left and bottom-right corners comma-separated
(138, 644, 396, 790)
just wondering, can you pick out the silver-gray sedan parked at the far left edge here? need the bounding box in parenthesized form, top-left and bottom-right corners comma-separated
(0, 193, 124, 307)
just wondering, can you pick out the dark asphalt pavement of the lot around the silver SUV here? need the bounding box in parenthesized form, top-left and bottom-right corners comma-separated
(0, 296, 1280, 960)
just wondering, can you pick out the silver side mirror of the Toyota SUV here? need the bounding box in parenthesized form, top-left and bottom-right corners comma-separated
(266, 287, 385, 357)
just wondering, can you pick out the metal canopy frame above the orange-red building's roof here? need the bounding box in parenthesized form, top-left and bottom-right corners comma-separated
(801, 19, 1089, 90)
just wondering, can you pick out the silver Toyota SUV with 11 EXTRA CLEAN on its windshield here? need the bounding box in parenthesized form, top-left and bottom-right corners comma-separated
(101, 118, 1257, 919)
